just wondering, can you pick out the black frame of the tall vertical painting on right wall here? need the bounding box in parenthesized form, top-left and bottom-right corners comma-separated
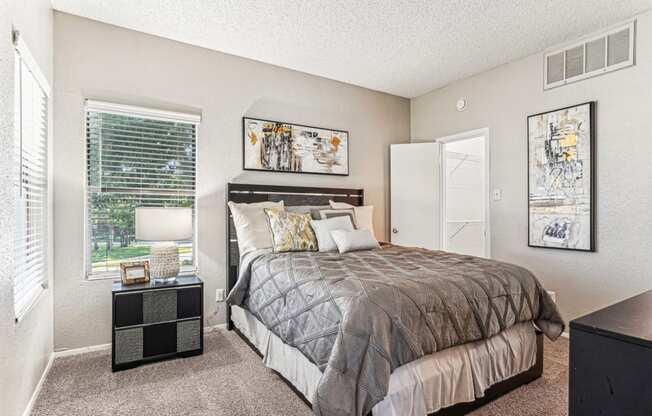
(525, 101, 597, 252)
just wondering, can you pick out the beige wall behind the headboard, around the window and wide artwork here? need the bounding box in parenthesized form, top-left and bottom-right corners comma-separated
(54, 13, 410, 349)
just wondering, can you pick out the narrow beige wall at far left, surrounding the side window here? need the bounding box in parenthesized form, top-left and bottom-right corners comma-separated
(0, 0, 53, 416)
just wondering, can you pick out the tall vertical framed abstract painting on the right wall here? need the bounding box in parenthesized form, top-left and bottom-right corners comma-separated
(527, 101, 595, 251)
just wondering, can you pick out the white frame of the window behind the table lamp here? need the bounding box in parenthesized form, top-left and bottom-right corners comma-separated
(82, 99, 201, 281)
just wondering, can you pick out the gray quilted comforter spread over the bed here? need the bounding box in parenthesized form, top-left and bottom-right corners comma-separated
(227, 246, 564, 416)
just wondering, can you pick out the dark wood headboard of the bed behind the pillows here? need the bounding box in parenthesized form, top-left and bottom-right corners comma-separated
(226, 183, 364, 330)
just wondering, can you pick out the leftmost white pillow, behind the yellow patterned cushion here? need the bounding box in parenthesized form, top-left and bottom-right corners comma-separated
(228, 201, 284, 256)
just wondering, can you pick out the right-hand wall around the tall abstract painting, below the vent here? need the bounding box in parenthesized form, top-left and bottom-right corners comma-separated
(411, 8, 652, 319)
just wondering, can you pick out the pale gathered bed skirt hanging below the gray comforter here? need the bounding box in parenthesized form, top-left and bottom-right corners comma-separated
(231, 305, 537, 416)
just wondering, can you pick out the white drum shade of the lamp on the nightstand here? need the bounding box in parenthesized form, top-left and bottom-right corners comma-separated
(136, 207, 192, 241)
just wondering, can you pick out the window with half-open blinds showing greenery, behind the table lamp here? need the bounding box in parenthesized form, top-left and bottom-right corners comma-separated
(86, 100, 199, 278)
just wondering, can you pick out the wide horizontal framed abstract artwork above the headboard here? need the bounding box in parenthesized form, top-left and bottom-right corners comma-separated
(242, 117, 349, 176)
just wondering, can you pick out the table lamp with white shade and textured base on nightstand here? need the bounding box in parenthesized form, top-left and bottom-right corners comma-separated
(136, 207, 192, 282)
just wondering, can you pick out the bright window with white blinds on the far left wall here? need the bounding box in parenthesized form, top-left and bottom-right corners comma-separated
(14, 32, 50, 321)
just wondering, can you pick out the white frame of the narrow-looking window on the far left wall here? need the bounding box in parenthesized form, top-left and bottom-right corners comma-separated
(12, 29, 53, 324)
